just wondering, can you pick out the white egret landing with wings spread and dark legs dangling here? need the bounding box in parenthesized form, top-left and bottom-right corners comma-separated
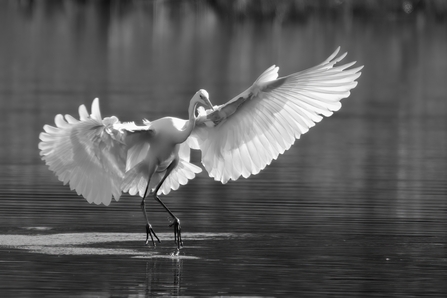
(39, 48, 363, 248)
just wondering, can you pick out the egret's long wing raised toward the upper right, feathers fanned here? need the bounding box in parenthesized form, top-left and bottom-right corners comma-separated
(188, 48, 363, 183)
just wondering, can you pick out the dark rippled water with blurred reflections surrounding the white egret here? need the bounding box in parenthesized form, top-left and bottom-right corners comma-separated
(0, 1, 447, 297)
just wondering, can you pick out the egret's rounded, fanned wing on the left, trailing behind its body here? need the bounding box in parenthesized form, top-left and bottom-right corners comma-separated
(39, 98, 126, 205)
